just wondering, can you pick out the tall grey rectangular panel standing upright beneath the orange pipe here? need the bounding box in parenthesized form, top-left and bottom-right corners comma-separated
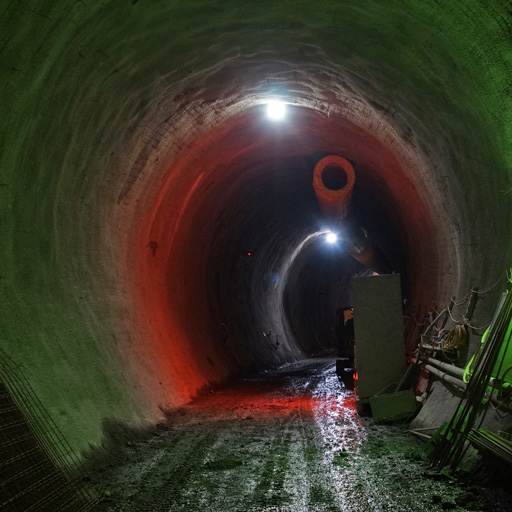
(352, 274, 405, 403)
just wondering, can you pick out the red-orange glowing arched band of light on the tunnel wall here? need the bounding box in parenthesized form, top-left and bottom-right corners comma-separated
(124, 107, 436, 403)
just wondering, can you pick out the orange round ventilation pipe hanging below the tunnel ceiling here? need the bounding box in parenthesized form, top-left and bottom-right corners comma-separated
(313, 155, 392, 274)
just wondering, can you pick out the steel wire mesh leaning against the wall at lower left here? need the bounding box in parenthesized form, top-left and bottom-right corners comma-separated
(0, 351, 95, 512)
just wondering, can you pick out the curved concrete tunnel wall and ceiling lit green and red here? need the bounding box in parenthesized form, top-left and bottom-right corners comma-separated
(0, 0, 512, 510)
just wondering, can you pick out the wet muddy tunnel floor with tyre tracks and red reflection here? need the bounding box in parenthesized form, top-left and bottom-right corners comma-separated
(92, 360, 507, 512)
